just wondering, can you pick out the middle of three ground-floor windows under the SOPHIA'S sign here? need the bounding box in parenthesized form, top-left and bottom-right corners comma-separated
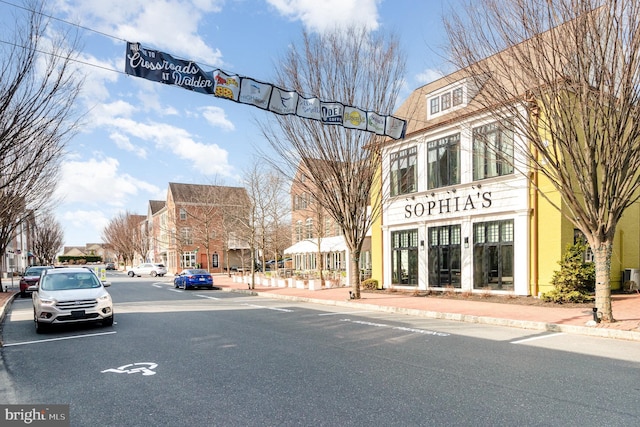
(429, 225, 461, 288)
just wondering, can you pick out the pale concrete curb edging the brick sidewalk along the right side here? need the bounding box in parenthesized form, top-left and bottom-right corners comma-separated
(222, 288, 640, 341)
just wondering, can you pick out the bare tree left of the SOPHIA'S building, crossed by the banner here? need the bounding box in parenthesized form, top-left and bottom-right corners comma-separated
(262, 28, 405, 298)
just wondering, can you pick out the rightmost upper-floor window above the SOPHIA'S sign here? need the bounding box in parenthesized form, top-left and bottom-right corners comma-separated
(473, 123, 513, 180)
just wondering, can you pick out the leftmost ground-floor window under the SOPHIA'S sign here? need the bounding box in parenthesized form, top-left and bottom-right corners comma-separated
(391, 230, 418, 286)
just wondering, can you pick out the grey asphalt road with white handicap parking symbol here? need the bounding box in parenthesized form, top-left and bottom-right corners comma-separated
(0, 272, 640, 426)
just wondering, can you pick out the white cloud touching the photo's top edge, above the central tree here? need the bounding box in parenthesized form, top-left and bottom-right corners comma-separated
(267, 0, 380, 32)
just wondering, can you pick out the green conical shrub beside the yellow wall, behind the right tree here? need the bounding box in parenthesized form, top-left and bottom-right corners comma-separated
(541, 239, 596, 303)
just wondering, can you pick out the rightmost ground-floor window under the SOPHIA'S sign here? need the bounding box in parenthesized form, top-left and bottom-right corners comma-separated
(473, 220, 513, 291)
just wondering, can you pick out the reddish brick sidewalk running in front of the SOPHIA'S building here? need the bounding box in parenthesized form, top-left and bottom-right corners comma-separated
(0, 275, 640, 342)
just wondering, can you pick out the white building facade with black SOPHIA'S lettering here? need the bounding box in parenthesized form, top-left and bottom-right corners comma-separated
(382, 83, 530, 295)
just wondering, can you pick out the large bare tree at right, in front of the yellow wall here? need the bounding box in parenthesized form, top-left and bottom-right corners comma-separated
(446, 0, 640, 321)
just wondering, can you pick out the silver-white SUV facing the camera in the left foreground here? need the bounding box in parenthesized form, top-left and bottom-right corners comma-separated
(29, 267, 113, 333)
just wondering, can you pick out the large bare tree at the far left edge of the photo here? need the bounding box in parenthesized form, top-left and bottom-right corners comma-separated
(0, 1, 82, 276)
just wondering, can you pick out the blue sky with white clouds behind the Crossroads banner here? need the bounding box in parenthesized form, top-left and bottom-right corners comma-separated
(0, 0, 459, 246)
